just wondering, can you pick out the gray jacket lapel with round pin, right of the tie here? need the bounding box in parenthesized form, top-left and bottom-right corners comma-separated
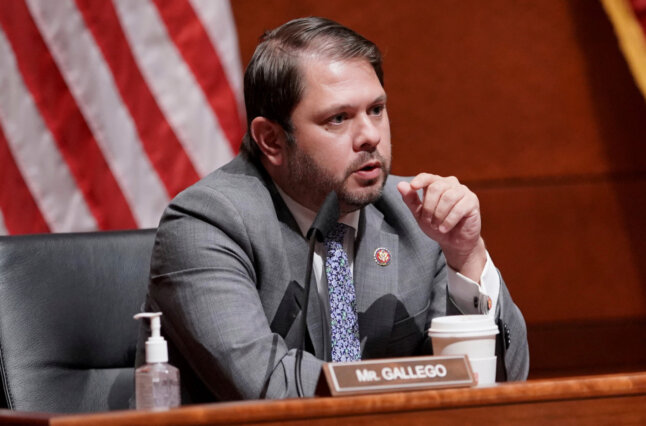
(354, 205, 399, 358)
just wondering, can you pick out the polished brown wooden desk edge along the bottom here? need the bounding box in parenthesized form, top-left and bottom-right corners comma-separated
(0, 373, 646, 426)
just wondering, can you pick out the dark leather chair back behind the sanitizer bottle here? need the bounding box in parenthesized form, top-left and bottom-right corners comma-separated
(0, 230, 155, 413)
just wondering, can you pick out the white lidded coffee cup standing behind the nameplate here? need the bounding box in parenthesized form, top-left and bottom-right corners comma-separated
(428, 315, 498, 385)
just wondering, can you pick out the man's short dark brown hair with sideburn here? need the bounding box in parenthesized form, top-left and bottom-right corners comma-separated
(241, 17, 384, 158)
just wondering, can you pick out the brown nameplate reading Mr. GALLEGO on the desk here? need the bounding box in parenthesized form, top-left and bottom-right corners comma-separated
(316, 355, 476, 396)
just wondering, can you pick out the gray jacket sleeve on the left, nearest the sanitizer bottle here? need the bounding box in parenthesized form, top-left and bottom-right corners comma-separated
(148, 186, 322, 400)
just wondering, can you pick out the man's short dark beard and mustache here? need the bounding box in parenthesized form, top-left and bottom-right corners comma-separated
(287, 141, 390, 213)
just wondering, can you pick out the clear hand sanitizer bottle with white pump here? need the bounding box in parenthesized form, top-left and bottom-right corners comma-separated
(135, 312, 180, 410)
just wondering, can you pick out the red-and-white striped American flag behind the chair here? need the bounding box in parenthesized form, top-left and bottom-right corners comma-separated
(0, 0, 244, 234)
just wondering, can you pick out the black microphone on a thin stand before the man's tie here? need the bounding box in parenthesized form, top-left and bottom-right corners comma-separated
(294, 191, 340, 397)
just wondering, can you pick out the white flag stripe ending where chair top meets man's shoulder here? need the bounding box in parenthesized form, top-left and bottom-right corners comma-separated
(28, 0, 172, 228)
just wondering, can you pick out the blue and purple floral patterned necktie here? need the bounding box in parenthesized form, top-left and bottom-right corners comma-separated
(325, 223, 361, 362)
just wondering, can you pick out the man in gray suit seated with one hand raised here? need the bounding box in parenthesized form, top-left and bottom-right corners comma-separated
(138, 18, 529, 403)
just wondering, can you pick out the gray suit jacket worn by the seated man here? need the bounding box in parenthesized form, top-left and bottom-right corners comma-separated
(137, 156, 529, 403)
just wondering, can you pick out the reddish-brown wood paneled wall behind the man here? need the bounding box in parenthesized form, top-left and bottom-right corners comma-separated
(232, 0, 646, 377)
